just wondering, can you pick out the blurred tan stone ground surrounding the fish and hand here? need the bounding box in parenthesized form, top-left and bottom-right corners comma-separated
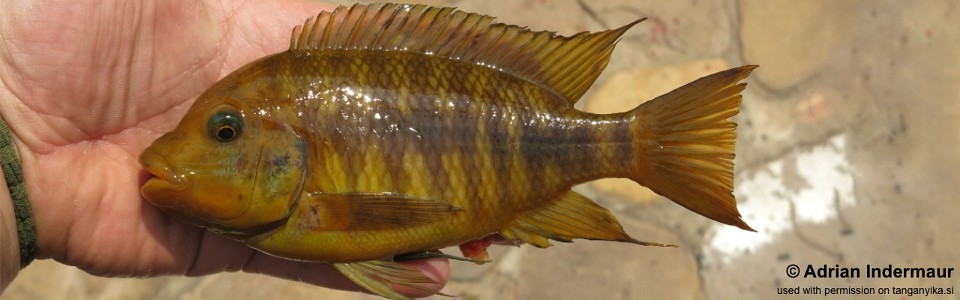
(0, 0, 960, 300)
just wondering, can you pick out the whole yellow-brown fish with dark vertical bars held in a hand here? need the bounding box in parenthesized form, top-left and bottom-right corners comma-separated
(139, 3, 756, 299)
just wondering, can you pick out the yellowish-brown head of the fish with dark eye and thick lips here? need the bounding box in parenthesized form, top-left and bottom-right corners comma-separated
(140, 89, 306, 236)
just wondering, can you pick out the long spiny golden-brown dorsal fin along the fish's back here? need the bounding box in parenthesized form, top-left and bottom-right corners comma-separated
(290, 4, 644, 103)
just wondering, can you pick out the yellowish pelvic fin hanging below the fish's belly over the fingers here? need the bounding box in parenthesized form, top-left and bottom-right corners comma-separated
(333, 260, 439, 299)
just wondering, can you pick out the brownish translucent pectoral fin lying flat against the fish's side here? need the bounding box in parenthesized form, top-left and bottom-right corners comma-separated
(307, 193, 460, 230)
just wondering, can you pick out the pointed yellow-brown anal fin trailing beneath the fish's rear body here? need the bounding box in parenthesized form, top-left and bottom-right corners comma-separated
(500, 191, 676, 248)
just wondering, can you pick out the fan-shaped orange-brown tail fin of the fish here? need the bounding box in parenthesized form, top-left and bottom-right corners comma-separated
(629, 66, 756, 231)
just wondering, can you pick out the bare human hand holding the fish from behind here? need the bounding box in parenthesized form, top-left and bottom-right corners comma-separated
(0, 0, 449, 296)
